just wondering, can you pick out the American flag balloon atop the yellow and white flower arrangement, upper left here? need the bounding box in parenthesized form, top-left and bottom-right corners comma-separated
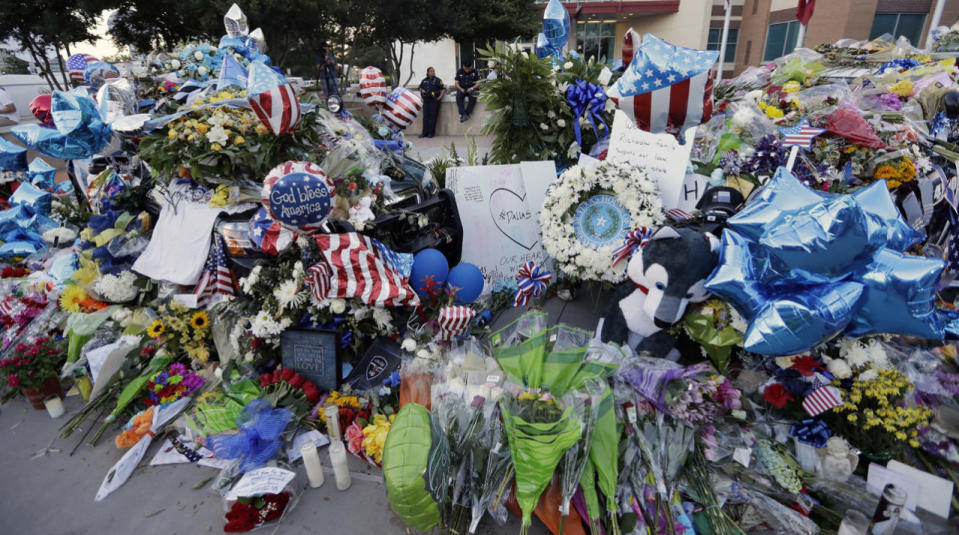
(246, 61, 300, 135)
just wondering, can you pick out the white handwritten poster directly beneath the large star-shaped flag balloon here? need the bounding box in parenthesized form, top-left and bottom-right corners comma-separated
(607, 110, 708, 212)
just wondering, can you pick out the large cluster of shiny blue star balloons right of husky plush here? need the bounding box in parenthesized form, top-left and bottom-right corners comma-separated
(706, 168, 945, 355)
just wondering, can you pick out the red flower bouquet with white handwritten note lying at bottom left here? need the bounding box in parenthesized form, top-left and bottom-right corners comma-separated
(223, 464, 305, 533)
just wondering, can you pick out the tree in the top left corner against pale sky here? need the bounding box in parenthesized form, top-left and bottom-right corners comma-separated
(0, 0, 107, 90)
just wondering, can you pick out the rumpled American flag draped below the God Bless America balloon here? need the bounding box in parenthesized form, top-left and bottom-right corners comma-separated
(305, 232, 419, 306)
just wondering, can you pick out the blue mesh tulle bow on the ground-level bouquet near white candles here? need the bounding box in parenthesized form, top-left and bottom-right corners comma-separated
(209, 399, 293, 473)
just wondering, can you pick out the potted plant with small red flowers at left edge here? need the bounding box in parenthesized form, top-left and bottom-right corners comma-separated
(0, 336, 67, 410)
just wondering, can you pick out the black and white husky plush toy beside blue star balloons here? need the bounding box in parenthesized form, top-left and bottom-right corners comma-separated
(596, 226, 719, 360)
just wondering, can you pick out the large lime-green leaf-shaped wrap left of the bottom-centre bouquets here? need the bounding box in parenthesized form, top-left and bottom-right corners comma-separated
(383, 403, 440, 531)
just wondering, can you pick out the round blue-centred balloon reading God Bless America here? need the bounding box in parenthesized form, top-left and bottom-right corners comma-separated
(260, 162, 336, 234)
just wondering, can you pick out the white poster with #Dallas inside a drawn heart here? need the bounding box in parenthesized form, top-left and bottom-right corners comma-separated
(446, 161, 556, 294)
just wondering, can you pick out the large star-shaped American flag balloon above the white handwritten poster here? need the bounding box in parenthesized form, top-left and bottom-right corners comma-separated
(608, 33, 719, 143)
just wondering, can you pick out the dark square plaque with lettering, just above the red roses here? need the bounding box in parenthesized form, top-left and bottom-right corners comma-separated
(280, 329, 340, 390)
